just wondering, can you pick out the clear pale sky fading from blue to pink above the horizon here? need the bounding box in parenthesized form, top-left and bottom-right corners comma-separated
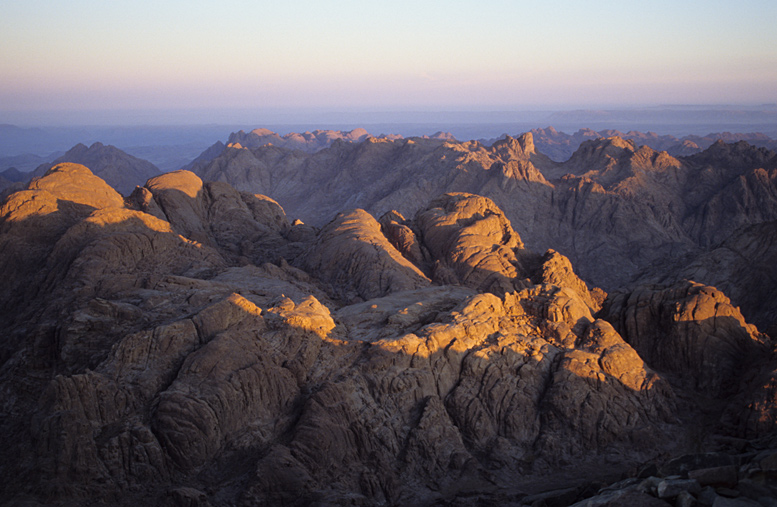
(0, 0, 777, 123)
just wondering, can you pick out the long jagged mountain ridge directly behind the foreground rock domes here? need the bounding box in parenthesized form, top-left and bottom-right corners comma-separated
(186, 133, 777, 306)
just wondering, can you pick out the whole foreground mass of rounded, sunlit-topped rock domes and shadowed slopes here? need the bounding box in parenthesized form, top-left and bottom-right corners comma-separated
(0, 165, 777, 506)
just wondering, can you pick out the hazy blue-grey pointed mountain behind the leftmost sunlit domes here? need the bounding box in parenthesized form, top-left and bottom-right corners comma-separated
(32, 142, 159, 195)
